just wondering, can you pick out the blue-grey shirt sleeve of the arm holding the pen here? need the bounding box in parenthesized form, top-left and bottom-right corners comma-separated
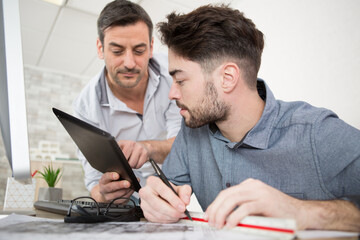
(162, 121, 191, 185)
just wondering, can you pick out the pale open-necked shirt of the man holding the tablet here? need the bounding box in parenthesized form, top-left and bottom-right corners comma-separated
(73, 54, 181, 191)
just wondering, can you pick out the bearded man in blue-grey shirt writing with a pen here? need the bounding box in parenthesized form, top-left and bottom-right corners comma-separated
(140, 5, 360, 231)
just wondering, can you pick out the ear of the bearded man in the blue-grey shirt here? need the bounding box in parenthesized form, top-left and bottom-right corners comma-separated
(221, 62, 240, 93)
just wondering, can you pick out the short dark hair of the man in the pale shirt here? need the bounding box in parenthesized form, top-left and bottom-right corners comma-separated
(97, 0, 153, 44)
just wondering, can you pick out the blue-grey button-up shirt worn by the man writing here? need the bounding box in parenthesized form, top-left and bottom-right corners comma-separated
(163, 80, 360, 210)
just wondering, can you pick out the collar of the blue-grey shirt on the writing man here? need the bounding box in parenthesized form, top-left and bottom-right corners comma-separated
(209, 79, 276, 149)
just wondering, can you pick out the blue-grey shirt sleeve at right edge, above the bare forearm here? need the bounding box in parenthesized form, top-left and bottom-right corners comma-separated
(312, 111, 360, 206)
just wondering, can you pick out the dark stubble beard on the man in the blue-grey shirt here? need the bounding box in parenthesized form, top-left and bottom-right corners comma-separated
(176, 79, 229, 128)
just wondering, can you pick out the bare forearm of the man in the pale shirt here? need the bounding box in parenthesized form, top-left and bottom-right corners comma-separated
(141, 137, 175, 164)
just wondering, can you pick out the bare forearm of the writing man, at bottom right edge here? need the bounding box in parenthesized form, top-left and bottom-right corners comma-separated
(303, 200, 360, 232)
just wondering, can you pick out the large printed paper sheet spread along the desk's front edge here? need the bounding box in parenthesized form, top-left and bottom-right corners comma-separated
(0, 214, 284, 240)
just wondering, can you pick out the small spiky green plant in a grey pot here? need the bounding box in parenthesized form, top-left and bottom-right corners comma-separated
(38, 164, 62, 201)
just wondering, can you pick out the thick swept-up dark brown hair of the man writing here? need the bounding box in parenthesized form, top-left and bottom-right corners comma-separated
(157, 5, 264, 88)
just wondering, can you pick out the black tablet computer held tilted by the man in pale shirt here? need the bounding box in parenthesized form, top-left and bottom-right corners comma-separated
(53, 108, 141, 192)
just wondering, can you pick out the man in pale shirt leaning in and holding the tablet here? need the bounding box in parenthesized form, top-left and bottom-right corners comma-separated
(74, 0, 181, 202)
